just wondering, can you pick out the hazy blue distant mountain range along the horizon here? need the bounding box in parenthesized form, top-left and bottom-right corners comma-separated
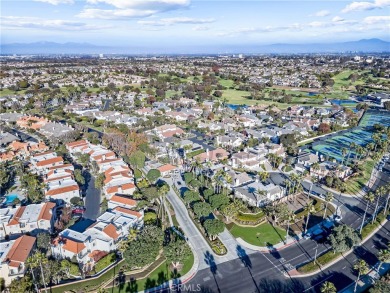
(0, 39, 390, 55)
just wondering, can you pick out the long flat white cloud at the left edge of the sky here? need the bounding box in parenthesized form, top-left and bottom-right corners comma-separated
(1, 16, 108, 31)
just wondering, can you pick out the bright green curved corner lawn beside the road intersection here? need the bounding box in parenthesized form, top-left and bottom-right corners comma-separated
(230, 223, 286, 246)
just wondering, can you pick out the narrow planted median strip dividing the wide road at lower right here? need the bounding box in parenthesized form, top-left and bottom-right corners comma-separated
(297, 213, 386, 276)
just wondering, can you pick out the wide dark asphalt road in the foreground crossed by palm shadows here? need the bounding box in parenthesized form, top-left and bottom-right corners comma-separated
(182, 222, 390, 293)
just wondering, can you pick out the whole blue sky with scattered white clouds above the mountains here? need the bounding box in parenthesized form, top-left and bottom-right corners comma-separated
(0, 0, 390, 48)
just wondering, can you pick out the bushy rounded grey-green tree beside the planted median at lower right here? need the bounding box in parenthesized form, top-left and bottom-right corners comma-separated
(329, 225, 360, 252)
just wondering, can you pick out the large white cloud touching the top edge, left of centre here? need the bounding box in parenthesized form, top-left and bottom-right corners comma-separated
(78, 0, 190, 19)
